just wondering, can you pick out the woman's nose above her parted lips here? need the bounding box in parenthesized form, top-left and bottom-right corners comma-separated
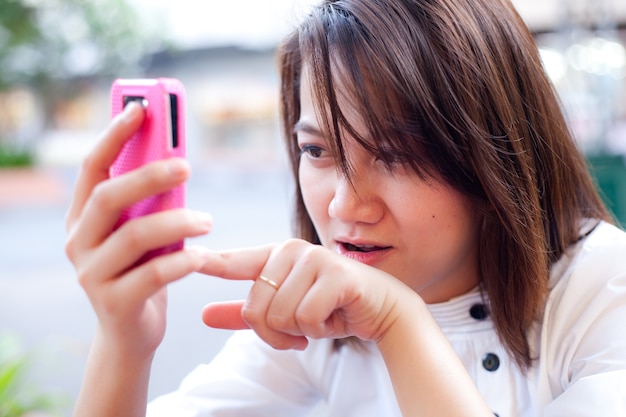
(328, 174, 385, 224)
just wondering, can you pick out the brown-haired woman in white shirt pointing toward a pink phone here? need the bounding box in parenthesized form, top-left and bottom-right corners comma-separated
(67, 0, 626, 417)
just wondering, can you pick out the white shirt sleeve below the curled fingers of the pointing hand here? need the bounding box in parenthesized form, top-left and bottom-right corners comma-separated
(147, 331, 320, 417)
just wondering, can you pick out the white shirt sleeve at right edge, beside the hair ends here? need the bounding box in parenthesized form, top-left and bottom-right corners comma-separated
(541, 224, 626, 417)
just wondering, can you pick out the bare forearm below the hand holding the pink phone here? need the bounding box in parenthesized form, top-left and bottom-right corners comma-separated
(73, 328, 153, 417)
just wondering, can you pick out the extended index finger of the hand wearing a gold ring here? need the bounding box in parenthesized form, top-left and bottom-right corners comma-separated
(198, 244, 276, 281)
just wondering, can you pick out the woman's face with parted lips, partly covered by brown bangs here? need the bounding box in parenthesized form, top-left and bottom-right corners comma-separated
(295, 71, 478, 303)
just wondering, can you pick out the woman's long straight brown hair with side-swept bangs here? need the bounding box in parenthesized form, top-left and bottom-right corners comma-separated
(278, 0, 608, 369)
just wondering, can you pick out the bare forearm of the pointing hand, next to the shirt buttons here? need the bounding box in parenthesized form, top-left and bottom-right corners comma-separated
(378, 298, 493, 417)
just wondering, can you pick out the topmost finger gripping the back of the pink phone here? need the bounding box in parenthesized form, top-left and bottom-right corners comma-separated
(65, 102, 144, 229)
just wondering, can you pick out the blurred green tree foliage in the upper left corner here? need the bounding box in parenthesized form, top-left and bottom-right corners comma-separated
(0, 0, 165, 91)
